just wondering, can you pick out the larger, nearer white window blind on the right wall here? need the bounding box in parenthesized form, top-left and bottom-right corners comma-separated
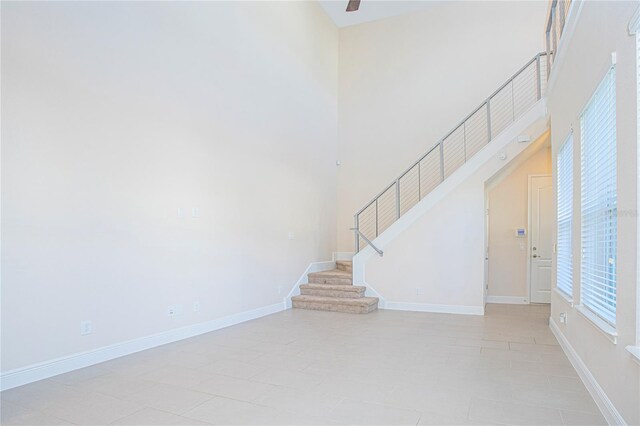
(580, 67, 618, 325)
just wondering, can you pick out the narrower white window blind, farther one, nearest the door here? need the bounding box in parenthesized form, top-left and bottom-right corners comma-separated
(556, 134, 573, 297)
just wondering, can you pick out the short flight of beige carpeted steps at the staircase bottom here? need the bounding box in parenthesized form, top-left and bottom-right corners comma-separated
(291, 260, 378, 314)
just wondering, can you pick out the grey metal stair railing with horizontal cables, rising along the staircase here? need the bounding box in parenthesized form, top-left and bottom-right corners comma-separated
(354, 53, 547, 252)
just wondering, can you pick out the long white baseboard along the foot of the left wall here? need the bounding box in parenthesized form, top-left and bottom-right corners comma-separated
(0, 303, 284, 391)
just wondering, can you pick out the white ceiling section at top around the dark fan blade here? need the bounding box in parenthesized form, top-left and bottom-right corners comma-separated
(318, 0, 437, 28)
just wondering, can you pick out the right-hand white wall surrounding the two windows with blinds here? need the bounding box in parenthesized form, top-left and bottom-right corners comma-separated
(548, 1, 640, 424)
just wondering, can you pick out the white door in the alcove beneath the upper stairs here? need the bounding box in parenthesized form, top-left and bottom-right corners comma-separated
(529, 176, 553, 303)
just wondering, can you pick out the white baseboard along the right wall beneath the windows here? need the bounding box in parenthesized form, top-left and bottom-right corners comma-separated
(549, 318, 627, 425)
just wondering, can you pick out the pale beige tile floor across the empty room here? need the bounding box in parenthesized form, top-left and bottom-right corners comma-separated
(0, 305, 606, 425)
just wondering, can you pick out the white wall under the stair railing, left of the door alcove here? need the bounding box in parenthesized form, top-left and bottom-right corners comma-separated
(354, 108, 549, 314)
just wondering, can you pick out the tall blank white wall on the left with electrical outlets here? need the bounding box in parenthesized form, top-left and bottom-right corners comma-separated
(1, 2, 338, 371)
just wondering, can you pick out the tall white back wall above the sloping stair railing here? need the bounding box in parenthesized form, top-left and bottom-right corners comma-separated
(338, 1, 547, 251)
